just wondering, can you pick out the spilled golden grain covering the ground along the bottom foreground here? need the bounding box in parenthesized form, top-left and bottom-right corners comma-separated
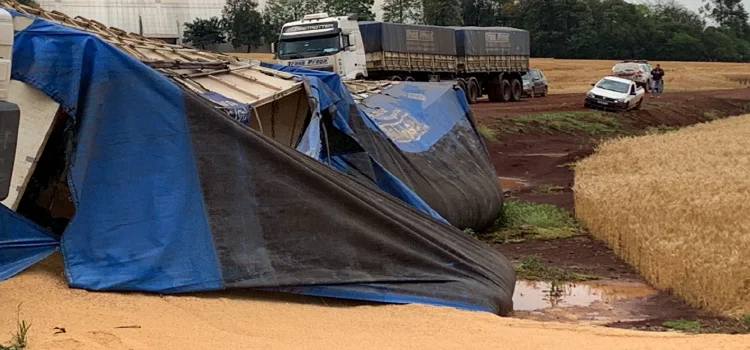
(0, 256, 750, 350)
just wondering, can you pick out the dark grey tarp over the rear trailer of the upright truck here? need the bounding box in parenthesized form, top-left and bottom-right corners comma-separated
(452, 27, 530, 56)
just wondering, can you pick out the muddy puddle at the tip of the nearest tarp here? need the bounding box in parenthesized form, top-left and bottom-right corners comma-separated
(513, 281, 656, 311)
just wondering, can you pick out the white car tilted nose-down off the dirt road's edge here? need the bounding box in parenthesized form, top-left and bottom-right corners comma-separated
(584, 77, 646, 111)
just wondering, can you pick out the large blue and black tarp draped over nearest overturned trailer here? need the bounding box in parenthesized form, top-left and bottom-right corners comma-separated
(0, 13, 515, 314)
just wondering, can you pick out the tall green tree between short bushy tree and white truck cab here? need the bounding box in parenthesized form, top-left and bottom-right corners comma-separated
(222, 0, 267, 52)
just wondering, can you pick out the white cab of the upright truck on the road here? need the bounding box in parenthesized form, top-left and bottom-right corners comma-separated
(271, 12, 367, 80)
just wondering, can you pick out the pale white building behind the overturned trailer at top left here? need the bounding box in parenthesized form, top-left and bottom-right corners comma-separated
(37, 0, 383, 42)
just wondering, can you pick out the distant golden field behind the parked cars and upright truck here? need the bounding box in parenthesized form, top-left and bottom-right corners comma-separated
(236, 53, 750, 94)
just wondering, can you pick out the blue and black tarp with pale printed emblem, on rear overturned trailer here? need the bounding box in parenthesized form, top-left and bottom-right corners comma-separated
(266, 64, 503, 230)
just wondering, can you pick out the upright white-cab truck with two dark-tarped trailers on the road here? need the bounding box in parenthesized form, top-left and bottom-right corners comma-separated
(272, 13, 529, 103)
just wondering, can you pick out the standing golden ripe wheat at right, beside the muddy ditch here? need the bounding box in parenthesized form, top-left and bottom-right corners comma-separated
(574, 115, 750, 315)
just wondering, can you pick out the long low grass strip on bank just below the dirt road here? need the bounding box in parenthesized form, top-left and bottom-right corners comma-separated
(500, 111, 622, 135)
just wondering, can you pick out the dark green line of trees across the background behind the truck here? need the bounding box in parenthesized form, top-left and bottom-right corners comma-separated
(184, 0, 750, 62)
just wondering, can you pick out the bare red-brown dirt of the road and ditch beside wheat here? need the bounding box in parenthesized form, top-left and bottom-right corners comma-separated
(472, 89, 750, 330)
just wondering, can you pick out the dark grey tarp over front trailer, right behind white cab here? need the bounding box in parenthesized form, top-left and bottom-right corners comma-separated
(359, 21, 456, 55)
